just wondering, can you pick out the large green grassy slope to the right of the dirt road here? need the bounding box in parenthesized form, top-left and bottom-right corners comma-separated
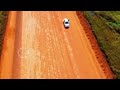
(83, 11, 120, 79)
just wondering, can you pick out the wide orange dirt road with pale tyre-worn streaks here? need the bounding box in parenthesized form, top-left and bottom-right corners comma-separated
(0, 11, 112, 79)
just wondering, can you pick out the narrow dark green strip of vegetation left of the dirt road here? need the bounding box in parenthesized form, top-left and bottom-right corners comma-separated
(0, 11, 7, 54)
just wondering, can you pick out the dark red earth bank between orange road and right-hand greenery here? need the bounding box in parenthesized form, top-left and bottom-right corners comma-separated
(76, 11, 114, 79)
